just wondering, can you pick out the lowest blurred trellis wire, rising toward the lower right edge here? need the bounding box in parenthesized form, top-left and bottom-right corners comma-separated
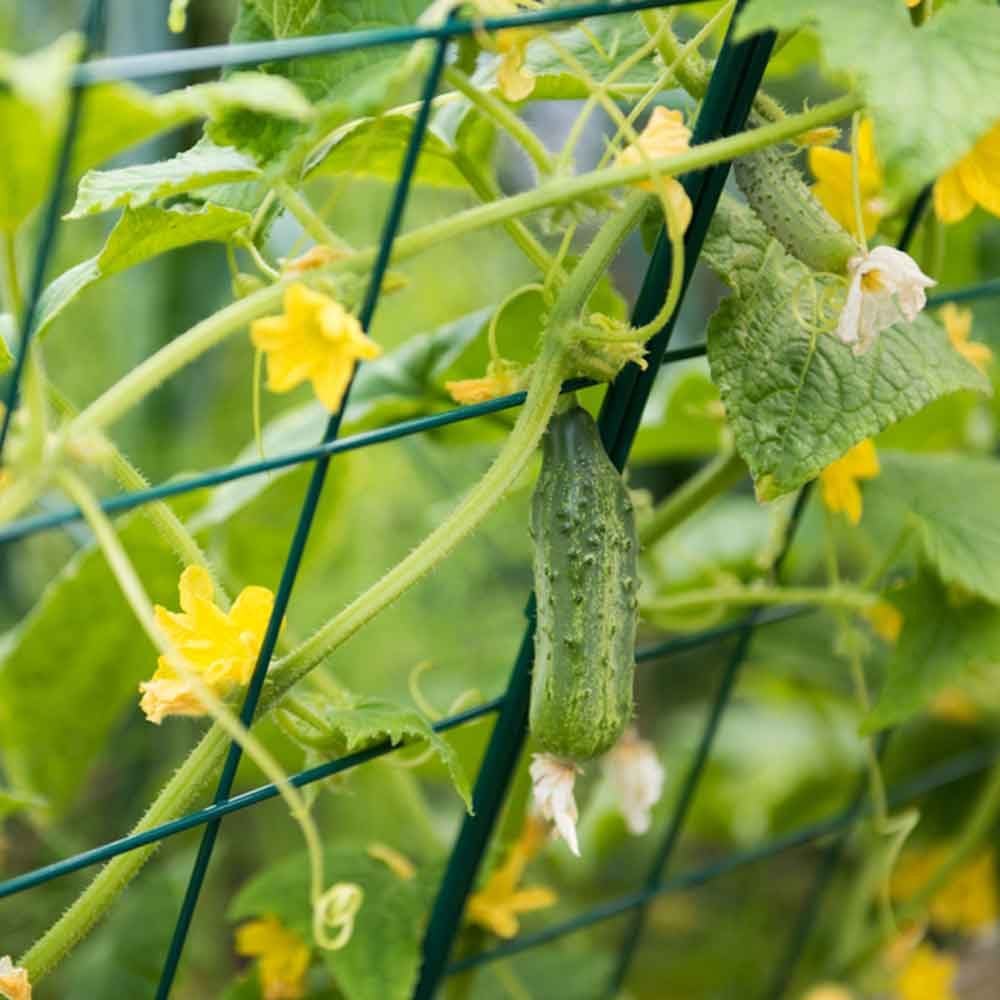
(448, 746, 1000, 975)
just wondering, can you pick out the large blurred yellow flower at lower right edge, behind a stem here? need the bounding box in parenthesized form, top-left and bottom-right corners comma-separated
(892, 845, 998, 934)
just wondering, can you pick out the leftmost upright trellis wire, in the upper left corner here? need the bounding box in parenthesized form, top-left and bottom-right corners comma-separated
(0, 0, 104, 456)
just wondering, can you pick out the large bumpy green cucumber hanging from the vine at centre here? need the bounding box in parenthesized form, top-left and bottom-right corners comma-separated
(530, 407, 638, 760)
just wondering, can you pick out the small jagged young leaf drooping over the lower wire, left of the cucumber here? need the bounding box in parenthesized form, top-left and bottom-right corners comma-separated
(288, 695, 472, 811)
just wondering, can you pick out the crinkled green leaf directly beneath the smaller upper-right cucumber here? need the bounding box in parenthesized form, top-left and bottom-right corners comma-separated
(706, 202, 991, 500)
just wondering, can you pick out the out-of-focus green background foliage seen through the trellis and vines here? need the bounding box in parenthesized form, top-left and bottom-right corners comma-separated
(0, 0, 1000, 1000)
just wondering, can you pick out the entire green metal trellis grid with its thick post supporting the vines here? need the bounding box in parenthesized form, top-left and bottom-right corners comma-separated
(0, 0, 1000, 1000)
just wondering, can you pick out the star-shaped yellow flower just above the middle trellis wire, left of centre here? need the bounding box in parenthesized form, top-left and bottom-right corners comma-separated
(250, 282, 381, 412)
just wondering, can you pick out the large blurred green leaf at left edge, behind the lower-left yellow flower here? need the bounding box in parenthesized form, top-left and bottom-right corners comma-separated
(0, 517, 177, 817)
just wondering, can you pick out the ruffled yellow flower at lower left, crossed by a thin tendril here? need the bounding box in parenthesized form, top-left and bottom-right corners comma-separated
(139, 566, 274, 725)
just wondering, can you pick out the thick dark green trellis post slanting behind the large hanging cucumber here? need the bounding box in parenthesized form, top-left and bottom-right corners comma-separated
(414, 9, 773, 1000)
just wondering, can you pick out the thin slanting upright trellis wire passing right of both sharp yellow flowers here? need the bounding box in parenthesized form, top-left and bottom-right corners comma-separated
(156, 31, 448, 1000)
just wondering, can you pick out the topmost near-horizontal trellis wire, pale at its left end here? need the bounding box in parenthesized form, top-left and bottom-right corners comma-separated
(76, 0, 697, 86)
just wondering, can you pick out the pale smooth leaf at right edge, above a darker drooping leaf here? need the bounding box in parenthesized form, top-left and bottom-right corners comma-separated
(865, 452, 1000, 604)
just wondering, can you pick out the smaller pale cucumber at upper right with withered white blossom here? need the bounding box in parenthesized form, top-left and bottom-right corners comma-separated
(733, 146, 861, 274)
